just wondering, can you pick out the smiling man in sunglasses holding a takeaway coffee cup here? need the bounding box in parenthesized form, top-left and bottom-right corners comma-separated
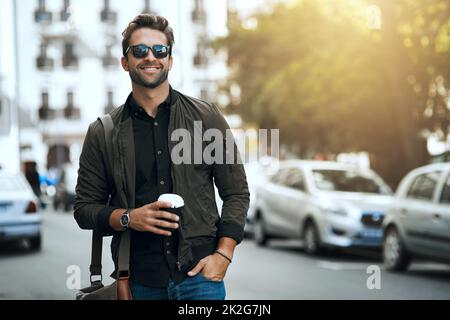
(74, 14, 249, 300)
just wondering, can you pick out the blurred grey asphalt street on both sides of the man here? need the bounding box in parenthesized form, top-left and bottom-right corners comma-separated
(0, 211, 450, 300)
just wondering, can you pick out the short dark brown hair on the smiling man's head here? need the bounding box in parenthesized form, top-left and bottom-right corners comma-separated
(122, 14, 175, 56)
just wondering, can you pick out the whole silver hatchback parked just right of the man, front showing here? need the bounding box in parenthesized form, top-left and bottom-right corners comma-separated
(255, 160, 392, 254)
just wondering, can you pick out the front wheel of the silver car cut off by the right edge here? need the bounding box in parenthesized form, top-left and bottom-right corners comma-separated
(383, 228, 411, 271)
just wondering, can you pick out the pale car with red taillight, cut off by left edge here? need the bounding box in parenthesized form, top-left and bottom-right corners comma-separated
(0, 172, 41, 250)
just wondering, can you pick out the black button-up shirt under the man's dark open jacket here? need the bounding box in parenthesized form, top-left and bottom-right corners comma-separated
(127, 88, 187, 287)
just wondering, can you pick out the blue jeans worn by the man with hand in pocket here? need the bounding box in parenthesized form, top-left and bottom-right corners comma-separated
(130, 272, 225, 300)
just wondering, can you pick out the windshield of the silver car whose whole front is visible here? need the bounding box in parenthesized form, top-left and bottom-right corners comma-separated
(312, 169, 391, 194)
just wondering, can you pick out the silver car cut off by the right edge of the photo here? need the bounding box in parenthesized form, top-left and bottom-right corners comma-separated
(383, 162, 450, 271)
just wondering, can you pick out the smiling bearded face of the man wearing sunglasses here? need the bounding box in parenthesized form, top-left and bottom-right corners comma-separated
(121, 28, 172, 89)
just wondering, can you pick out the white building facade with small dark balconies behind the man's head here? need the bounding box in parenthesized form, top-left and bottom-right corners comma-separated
(14, 0, 227, 174)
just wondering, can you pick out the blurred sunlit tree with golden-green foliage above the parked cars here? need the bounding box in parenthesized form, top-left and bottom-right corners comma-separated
(217, 0, 450, 185)
